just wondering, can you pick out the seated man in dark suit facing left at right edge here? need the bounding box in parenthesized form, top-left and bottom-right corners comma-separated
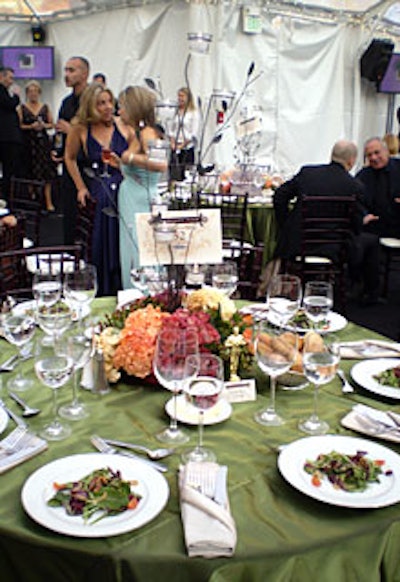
(357, 137, 400, 238)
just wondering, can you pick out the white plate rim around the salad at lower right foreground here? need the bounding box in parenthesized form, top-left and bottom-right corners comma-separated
(278, 435, 400, 509)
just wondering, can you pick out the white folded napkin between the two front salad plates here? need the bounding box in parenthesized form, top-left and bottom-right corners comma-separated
(179, 462, 237, 558)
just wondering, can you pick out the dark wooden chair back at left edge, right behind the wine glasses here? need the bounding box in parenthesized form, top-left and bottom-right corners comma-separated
(0, 244, 82, 301)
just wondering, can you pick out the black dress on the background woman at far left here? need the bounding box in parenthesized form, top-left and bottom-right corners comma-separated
(21, 104, 57, 182)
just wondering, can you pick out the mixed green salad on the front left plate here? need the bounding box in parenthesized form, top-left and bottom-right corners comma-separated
(47, 468, 141, 524)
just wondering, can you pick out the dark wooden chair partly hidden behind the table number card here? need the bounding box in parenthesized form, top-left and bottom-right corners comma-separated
(197, 192, 252, 261)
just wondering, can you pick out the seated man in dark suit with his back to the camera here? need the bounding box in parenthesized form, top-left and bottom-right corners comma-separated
(274, 140, 379, 303)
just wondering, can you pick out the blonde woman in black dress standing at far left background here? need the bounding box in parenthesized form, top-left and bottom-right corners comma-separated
(17, 81, 57, 212)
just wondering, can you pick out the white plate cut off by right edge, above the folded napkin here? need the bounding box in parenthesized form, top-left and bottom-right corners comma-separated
(350, 358, 400, 399)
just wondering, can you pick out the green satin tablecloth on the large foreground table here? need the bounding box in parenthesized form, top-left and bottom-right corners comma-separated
(0, 299, 400, 582)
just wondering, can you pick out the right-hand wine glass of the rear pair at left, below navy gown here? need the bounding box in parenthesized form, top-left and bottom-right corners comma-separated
(64, 264, 97, 335)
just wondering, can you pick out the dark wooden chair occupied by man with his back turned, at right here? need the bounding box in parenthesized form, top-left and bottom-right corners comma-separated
(288, 196, 356, 311)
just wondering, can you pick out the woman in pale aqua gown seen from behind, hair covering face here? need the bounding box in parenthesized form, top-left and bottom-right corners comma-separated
(118, 87, 168, 289)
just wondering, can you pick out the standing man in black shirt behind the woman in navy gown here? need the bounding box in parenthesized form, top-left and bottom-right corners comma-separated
(56, 57, 89, 244)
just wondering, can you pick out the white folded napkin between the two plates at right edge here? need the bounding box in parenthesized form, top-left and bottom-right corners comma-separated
(341, 404, 400, 443)
